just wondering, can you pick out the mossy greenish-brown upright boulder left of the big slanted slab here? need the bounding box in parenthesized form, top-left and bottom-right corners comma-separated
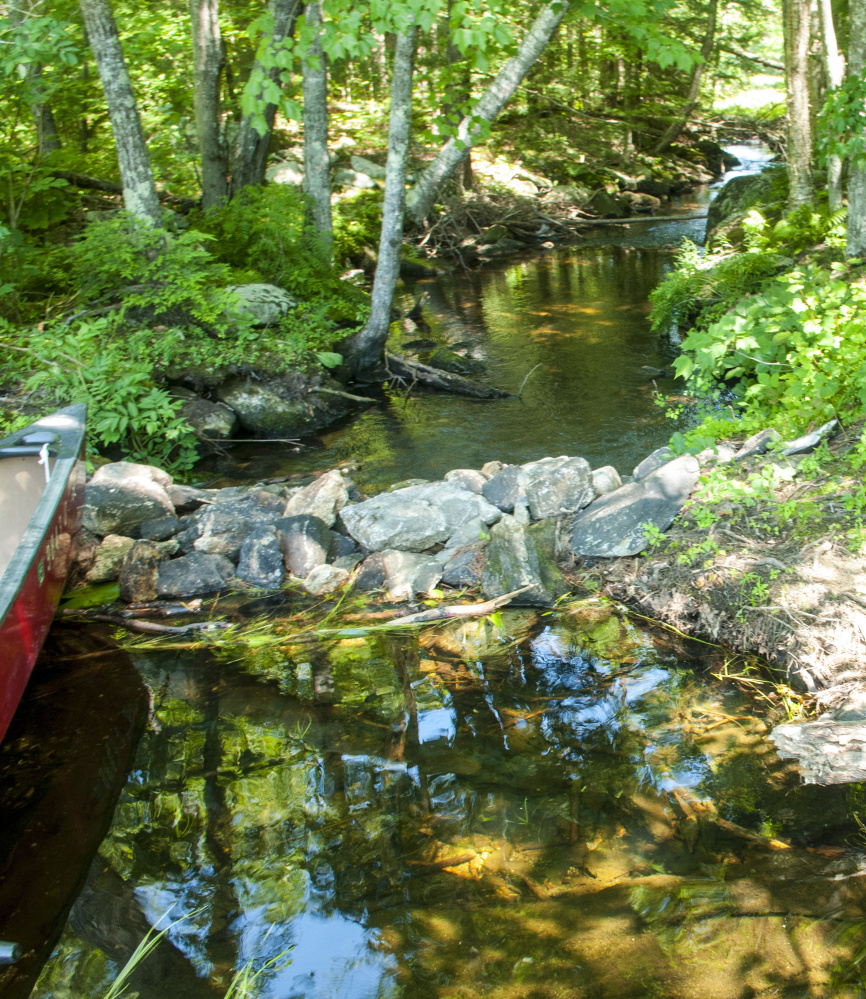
(481, 514, 565, 607)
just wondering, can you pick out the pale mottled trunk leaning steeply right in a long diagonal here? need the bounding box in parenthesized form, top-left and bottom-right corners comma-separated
(407, 0, 569, 224)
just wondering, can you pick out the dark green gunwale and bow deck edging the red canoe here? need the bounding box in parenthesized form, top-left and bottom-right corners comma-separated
(0, 404, 87, 625)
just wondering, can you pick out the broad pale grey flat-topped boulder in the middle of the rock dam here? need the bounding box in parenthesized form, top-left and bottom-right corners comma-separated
(340, 482, 502, 552)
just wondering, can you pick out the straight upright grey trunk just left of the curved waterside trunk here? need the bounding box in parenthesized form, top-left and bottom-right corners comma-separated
(304, 0, 334, 260)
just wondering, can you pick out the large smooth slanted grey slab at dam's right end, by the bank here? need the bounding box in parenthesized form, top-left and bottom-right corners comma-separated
(570, 454, 700, 558)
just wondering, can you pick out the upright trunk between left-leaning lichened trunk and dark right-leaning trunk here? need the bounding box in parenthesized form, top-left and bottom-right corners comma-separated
(189, 0, 228, 211)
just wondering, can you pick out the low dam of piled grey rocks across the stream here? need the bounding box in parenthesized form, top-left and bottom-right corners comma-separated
(78, 449, 699, 606)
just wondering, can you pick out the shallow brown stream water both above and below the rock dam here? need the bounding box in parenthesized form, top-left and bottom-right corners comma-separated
(10, 147, 866, 999)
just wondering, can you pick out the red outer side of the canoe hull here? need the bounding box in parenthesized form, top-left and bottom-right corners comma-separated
(0, 404, 84, 740)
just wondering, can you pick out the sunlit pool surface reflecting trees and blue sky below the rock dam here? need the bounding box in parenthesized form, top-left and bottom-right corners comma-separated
(35, 605, 866, 999)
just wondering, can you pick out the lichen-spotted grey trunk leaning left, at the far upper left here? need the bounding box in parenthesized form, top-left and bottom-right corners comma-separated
(80, 0, 162, 226)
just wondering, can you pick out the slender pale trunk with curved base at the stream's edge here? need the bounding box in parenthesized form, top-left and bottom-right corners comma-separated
(350, 25, 418, 369)
